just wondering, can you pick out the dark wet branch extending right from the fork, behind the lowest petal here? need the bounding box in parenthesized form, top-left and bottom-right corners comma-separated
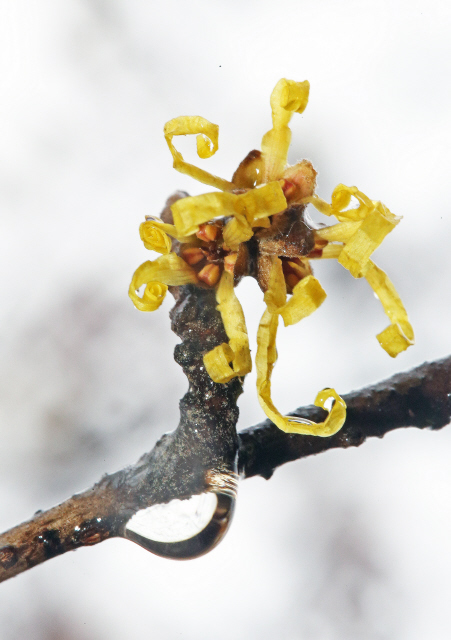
(239, 356, 451, 478)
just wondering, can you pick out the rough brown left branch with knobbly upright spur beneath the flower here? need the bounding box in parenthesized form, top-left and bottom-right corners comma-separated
(0, 286, 242, 582)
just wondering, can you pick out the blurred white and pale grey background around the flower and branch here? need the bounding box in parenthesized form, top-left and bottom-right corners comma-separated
(0, 0, 451, 640)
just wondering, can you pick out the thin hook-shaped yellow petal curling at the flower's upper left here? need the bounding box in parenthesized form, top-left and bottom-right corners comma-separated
(164, 116, 235, 191)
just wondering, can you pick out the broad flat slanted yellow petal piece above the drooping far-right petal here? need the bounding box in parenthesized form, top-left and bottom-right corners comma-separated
(338, 202, 401, 278)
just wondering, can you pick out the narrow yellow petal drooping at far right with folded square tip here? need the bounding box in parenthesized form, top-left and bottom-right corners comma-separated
(365, 260, 415, 358)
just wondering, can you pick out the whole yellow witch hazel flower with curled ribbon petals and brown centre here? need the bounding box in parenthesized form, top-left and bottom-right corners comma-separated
(129, 79, 414, 436)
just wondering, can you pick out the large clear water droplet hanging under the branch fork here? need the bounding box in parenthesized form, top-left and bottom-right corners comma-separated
(124, 470, 238, 560)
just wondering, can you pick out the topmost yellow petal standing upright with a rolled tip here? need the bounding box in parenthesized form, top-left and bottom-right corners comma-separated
(262, 78, 310, 182)
